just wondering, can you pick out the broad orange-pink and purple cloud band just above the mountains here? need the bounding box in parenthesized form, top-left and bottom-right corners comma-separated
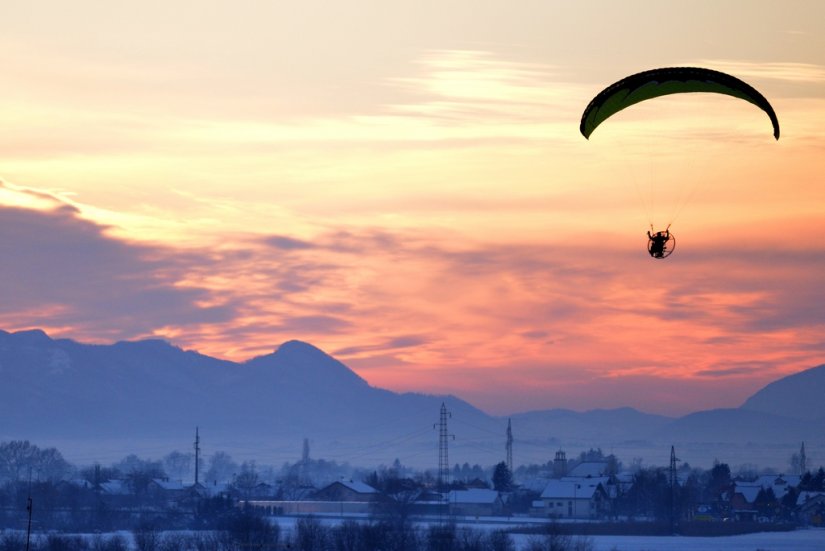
(0, 164, 825, 418)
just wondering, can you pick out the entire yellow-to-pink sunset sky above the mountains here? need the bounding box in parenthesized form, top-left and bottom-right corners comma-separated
(0, 0, 825, 415)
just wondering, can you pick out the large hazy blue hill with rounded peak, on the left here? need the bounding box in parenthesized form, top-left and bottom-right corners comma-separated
(0, 330, 490, 464)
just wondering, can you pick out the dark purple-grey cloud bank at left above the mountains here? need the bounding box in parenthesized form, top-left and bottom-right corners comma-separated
(0, 203, 232, 341)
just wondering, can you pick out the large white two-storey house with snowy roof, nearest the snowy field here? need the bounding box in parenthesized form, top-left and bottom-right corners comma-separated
(534, 477, 610, 519)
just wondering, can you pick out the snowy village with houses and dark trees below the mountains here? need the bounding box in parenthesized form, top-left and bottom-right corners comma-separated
(0, 442, 825, 544)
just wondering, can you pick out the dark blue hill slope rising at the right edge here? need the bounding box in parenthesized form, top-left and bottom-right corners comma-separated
(740, 365, 825, 421)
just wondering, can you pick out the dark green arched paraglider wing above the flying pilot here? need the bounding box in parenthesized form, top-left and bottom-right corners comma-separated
(579, 67, 779, 140)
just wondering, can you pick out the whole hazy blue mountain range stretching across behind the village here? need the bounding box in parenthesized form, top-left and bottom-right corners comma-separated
(0, 330, 825, 470)
